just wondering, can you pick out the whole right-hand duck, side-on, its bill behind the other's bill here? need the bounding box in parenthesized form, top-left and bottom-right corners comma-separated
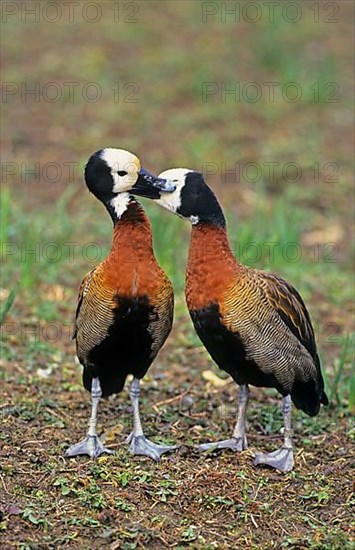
(132, 168, 328, 471)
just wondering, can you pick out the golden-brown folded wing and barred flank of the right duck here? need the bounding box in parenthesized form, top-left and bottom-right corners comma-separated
(220, 269, 319, 393)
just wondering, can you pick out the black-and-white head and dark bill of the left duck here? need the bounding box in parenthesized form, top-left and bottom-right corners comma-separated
(85, 147, 175, 205)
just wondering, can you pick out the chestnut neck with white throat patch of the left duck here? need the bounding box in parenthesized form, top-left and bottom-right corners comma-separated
(108, 193, 154, 269)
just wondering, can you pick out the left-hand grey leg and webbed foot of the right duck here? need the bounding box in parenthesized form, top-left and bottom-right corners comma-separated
(198, 384, 250, 451)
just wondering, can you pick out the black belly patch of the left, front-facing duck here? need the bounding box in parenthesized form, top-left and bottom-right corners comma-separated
(78, 297, 156, 397)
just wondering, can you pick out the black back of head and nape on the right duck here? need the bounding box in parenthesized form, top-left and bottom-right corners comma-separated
(177, 172, 226, 227)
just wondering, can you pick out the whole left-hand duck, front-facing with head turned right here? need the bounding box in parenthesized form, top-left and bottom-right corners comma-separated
(66, 148, 176, 460)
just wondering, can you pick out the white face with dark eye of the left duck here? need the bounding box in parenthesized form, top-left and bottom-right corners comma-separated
(101, 147, 141, 193)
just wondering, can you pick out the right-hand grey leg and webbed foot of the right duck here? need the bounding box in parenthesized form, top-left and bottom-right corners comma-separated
(254, 395, 294, 472)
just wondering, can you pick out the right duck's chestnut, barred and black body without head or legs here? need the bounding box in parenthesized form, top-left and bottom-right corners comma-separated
(186, 224, 328, 416)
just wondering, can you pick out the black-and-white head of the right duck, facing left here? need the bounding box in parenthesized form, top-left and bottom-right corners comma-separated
(132, 168, 225, 226)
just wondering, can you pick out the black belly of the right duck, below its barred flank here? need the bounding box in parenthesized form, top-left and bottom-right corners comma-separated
(190, 304, 286, 395)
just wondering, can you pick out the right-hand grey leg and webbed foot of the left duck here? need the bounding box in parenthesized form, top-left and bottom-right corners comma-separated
(127, 378, 177, 460)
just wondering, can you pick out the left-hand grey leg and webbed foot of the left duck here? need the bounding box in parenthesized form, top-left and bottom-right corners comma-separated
(65, 378, 113, 458)
